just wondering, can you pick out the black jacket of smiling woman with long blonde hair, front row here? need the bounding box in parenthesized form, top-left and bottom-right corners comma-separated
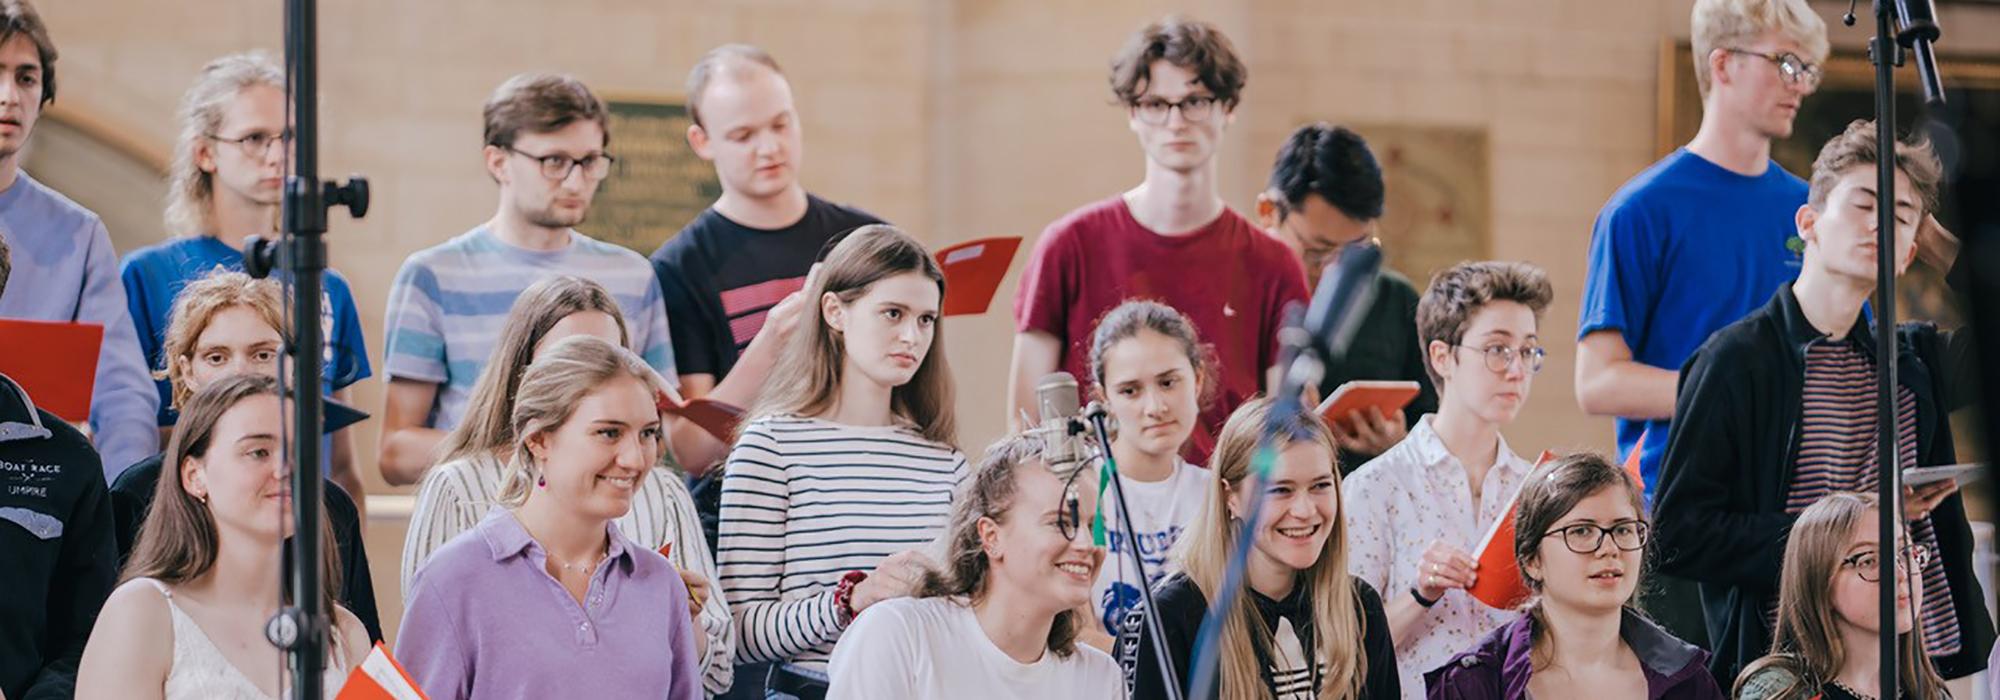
(1118, 574, 1402, 700)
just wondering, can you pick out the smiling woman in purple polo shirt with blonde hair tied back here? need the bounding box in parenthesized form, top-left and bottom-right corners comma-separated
(396, 336, 702, 700)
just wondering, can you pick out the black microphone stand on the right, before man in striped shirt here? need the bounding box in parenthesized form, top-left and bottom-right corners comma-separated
(1842, 0, 1944, 698)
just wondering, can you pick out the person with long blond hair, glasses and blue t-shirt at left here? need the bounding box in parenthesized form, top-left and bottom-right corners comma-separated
(120, 52, 370, 504)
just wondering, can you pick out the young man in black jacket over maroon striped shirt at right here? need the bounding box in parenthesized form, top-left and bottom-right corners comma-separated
(1654, 122, 1994, 680)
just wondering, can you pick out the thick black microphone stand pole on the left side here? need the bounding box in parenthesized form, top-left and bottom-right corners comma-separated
(244, 0, 368, 700)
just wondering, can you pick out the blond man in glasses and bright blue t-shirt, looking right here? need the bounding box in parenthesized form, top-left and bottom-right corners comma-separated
(1576, 0, 1828, 644)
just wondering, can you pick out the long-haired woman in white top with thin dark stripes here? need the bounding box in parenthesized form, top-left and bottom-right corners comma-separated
(720, 226, 966, 698)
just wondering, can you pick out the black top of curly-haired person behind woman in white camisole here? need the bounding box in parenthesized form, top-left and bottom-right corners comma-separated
(112, 454, 382, 642)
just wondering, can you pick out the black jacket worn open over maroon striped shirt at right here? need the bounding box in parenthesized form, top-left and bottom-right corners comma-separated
(1654, 284, 1994, 688)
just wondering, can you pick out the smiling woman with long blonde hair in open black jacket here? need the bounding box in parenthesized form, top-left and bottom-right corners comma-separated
(1120, 398, 1402, 700)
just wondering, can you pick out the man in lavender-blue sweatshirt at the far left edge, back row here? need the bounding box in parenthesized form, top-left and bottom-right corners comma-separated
(0, 0, 160, 482)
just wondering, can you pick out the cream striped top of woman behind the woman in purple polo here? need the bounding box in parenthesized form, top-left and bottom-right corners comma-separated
(402, 456, 736, 694)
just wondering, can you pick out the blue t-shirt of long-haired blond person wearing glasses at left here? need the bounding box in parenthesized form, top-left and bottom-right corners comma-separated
(118, 236, 372, 426)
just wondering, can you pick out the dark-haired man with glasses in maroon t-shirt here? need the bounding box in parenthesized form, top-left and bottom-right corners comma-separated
(1008, 16, 1306, 464)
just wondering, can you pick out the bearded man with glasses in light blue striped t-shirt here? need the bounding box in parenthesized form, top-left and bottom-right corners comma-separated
(382, 74, 676, 484)
